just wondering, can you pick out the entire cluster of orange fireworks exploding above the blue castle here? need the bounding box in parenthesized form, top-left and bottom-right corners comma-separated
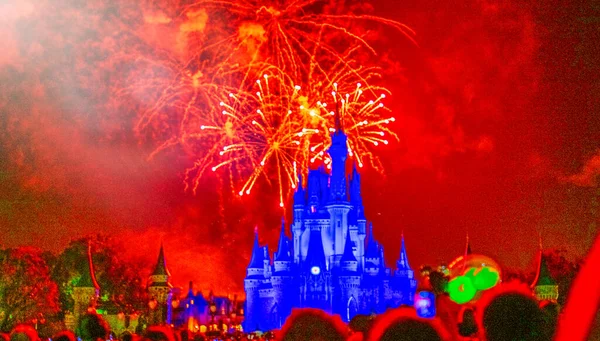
(115, 0, 413, 206)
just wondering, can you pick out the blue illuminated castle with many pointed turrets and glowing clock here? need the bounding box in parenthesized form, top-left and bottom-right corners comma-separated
(244, 118, 417, 331)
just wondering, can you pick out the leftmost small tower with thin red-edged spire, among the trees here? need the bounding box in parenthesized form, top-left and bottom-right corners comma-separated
(73, 243, 100, 326)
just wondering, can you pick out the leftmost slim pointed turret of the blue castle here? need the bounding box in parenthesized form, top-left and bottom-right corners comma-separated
(244, 228, 265, 330)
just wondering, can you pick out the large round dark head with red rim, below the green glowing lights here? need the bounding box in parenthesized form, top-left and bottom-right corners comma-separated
(477, 283, 550, 341)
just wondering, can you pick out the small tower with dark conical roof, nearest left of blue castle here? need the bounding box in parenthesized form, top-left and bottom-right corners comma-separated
(148, 244, 172, 325)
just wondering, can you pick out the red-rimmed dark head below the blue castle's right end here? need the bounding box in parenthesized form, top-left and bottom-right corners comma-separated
(368, 308, 448, 341)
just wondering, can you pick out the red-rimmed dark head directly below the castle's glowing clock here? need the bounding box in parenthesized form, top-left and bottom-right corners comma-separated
(277, 309, 347, 341)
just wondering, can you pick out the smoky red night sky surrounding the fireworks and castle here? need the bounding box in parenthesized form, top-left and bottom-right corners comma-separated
(0, 0, 600, 292)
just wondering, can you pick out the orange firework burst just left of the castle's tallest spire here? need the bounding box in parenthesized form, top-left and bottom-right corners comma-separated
(186, 72, 319, 207)
